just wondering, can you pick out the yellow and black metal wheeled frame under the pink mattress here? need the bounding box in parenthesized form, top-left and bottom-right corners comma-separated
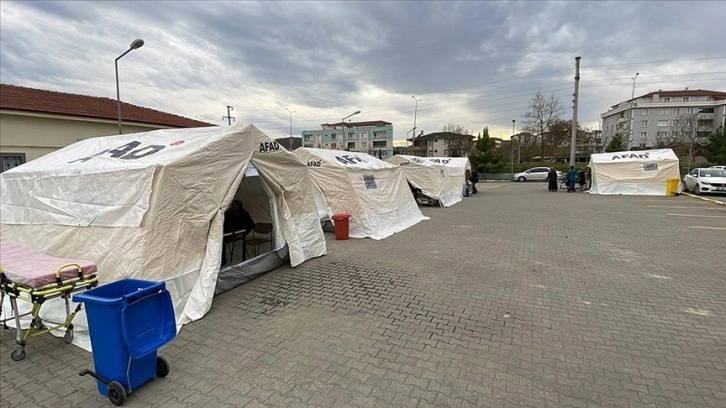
(0, 263, 98, 361)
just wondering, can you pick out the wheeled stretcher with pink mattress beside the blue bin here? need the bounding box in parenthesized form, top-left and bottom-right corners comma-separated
(0, 243, 98, 361)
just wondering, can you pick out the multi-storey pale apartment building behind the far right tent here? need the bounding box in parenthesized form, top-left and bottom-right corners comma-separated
(600, 89, 726, 149)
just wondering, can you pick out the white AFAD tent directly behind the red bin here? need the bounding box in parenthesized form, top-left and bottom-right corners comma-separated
(293, 147, 427, 239)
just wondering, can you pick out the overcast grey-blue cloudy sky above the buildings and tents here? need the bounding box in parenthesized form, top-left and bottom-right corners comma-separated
(0, 1, 726, 139)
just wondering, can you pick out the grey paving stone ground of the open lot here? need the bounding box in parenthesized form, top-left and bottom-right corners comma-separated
(0, 183, 726, 408)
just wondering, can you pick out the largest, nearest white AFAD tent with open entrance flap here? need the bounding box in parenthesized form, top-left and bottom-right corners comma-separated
(0, 125, 326, 347)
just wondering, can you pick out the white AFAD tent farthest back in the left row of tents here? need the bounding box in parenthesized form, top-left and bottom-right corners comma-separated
(386, 154, 464, 207)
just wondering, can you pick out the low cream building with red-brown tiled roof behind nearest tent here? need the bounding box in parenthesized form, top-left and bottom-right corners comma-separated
(0, 84, 212, 171)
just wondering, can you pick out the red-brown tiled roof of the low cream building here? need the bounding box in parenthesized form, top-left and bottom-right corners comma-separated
(0, 84, 214, 128)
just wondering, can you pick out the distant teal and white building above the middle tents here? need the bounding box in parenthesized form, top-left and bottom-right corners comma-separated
(302, 120, 393, 160)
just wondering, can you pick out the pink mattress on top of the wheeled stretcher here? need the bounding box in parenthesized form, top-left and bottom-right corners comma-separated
(0, 243, 96, 288)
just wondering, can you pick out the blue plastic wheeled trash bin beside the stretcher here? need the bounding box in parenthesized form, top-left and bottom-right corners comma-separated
(73, 279, 176, 405)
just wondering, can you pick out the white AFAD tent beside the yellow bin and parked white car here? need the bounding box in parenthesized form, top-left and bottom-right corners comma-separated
(590, 149, 680, 196)
